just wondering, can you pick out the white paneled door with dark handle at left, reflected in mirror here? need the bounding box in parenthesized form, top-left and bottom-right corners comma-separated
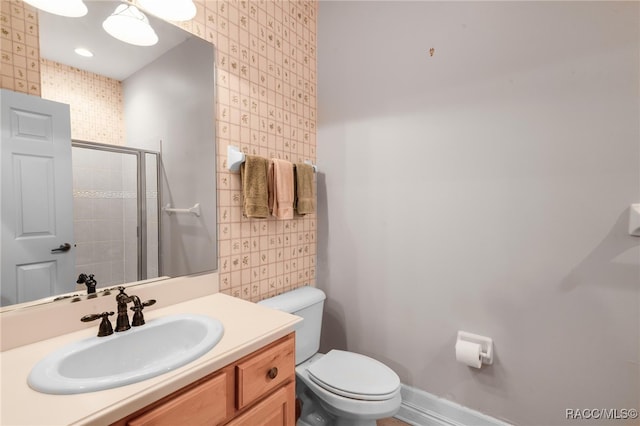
(0, 90, 75, 306)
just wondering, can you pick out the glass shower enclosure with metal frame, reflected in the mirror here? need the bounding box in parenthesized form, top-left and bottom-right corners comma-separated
(72, 141, 162, 287)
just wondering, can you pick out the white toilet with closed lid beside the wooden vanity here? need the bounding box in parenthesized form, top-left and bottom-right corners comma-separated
(258, 287, 402, 426)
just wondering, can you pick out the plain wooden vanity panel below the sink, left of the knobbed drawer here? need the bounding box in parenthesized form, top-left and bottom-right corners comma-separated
(127, 373, 231, 426)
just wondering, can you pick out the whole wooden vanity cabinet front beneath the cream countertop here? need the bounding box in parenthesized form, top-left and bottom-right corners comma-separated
(112, 333, 295, 426)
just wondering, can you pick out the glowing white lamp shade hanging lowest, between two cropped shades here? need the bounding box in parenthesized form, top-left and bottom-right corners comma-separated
(102, 4, 158, 46)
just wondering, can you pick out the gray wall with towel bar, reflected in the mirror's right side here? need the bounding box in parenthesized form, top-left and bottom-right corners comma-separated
(123, 37, 217, 276)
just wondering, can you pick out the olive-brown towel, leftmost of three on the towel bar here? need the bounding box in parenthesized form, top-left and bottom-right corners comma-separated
(240, 155, 269, 218)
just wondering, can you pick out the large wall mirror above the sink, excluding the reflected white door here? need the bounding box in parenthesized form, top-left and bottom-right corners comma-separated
(2, 0, 217, 310)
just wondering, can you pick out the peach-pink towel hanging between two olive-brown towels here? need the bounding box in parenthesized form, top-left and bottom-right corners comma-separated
(269, 158, 295, 219)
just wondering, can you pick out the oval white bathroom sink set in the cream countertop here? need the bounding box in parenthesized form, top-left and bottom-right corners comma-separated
(27, 314, 224, 394)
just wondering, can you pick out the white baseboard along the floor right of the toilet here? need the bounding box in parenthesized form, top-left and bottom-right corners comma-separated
(394, 385, 509, 426)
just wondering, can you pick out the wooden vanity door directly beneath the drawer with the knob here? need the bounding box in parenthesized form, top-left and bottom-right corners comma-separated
(227, 382, 296, 426)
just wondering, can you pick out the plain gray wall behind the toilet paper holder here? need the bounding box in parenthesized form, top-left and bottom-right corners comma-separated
(318, 1, 640, 425)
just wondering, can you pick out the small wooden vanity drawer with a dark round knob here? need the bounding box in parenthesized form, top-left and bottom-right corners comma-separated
(236, 334, 295, 409)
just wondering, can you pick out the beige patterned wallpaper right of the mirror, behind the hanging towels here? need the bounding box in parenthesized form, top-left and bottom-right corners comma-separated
(2, 0, 317, 301)
